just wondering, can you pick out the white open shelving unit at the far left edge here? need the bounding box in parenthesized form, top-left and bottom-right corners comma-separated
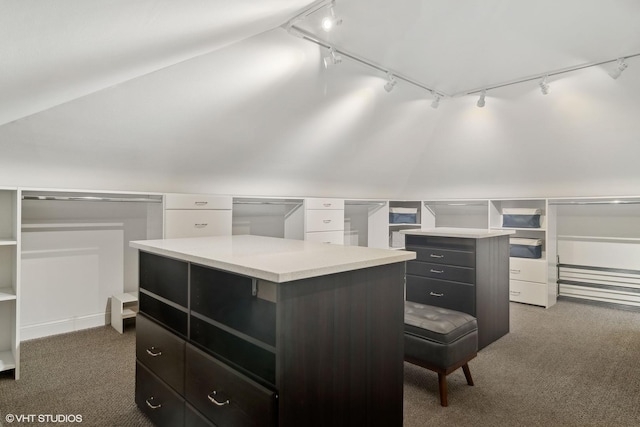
(0, 187, 20, 379)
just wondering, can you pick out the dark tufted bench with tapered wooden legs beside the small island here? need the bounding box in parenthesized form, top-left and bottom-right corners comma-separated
(404, 301, 478, 406)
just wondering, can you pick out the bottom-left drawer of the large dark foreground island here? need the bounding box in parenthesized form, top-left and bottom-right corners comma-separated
(135, 362, 184, 427)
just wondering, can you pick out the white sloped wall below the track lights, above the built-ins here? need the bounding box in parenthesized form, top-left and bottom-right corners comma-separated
(0, 29, 640, 198)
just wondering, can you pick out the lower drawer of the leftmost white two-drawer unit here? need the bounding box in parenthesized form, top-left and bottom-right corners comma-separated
(164, 209, 231, 239)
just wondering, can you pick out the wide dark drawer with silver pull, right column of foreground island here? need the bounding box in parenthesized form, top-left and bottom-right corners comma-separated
(185, 344, 277, 427)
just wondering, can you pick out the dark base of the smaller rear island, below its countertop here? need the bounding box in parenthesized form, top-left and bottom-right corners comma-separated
(406, 234, 509, 349)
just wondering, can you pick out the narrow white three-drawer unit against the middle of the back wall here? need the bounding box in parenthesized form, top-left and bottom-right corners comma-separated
(304, 199, 344, 245)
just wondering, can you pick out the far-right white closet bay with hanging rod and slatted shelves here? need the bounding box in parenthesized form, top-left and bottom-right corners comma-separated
(549, 197, 640, 310)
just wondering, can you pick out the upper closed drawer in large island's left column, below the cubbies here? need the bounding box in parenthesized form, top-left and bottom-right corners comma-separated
(136, 314, 185, 394)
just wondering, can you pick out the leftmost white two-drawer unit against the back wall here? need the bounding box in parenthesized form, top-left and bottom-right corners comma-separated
(164, 194, 233, 239)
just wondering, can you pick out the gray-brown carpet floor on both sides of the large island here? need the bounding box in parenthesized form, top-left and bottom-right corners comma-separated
(0, 301, 640, 427)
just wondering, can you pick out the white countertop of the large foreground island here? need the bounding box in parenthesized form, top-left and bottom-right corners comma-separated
(129, 235, 416, 283)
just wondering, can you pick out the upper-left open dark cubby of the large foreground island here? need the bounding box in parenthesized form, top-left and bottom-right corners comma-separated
(139, 251, 189, 307)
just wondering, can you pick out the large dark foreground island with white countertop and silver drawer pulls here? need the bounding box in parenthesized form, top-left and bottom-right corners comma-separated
(131, 235, 415, 426)
